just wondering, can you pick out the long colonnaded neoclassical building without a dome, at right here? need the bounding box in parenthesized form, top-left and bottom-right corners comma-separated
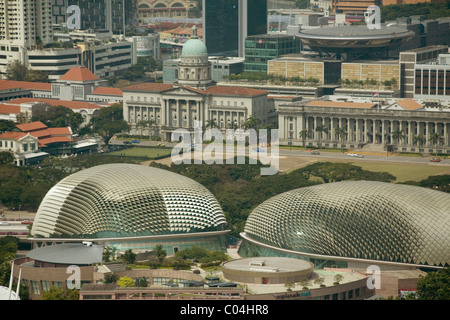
(278, 99, 450, 154)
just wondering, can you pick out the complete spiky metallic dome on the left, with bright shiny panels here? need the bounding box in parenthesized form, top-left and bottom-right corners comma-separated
(31, 164, 226, 239)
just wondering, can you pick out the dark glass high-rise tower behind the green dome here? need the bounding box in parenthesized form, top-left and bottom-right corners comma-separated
(202, 0, 267, 57)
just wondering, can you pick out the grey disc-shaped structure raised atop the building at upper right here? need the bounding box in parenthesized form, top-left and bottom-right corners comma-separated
(296, 26, 415, 53)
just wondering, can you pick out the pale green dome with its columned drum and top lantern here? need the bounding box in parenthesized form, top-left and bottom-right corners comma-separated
(178, 25, 213, 89)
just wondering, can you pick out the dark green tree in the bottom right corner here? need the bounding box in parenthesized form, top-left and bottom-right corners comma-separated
(417, 267, 450, 300)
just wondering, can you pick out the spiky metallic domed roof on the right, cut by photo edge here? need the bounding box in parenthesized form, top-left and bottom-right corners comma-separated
(240, 181, 450, 267)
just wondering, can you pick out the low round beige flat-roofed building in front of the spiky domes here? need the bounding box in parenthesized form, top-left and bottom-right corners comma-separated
(222, 257, 314, 284)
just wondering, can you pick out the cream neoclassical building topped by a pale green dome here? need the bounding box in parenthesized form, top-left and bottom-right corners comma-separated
(123, 26, 273, 140)
